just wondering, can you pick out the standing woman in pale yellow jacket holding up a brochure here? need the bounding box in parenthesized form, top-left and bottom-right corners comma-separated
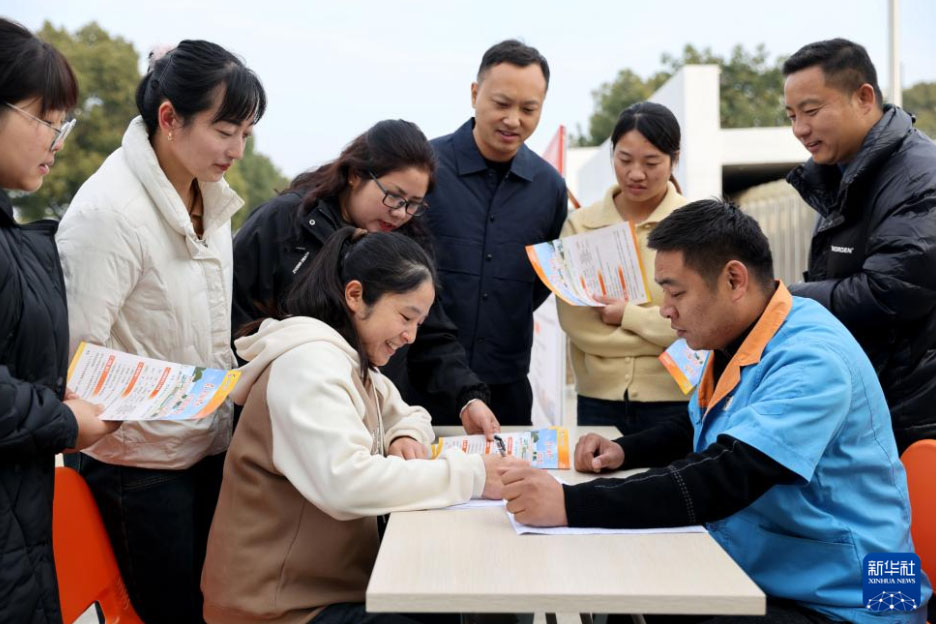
(558, 102, 687, 434)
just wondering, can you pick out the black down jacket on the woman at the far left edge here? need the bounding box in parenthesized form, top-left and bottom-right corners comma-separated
(0, 191, 78, 624)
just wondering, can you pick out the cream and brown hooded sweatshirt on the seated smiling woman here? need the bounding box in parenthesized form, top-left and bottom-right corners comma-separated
(202, 317, 485, 624)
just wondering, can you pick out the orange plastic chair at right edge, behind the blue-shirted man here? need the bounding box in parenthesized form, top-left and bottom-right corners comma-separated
(900, 440, 936, 613)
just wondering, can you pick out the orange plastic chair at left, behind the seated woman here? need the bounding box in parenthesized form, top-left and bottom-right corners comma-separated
(52, 468, 143, 624)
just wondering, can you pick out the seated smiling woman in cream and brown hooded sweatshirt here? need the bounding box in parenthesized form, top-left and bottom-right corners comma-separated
(202, 228, 505, 624)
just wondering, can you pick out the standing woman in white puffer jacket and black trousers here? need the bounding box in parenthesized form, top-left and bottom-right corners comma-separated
(57, 40, 266, 624)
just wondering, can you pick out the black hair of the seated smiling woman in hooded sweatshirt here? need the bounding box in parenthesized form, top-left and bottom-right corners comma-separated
(276, 227, 437, 381)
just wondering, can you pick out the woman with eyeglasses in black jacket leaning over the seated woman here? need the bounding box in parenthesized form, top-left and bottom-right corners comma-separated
(232, 120, 500, 437)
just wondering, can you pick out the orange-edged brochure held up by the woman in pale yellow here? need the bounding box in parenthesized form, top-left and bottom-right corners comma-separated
(526, 221, 650, 307)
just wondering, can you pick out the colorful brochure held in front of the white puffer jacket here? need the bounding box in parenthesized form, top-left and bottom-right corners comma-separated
(67, 342, 240, 420)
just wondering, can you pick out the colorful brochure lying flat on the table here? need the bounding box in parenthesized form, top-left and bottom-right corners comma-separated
(431, 427, 572, 470)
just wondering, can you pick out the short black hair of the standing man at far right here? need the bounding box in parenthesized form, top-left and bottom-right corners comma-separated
(783, 38, 884, 108)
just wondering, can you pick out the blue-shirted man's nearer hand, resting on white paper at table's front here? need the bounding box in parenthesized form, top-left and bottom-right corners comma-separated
(502, 467, 569, 526)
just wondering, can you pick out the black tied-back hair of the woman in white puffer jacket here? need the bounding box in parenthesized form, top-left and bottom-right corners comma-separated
(136, 39, 266, 137)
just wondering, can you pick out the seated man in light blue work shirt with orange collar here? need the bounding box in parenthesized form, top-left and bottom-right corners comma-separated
(503, 200, 931, 624)
